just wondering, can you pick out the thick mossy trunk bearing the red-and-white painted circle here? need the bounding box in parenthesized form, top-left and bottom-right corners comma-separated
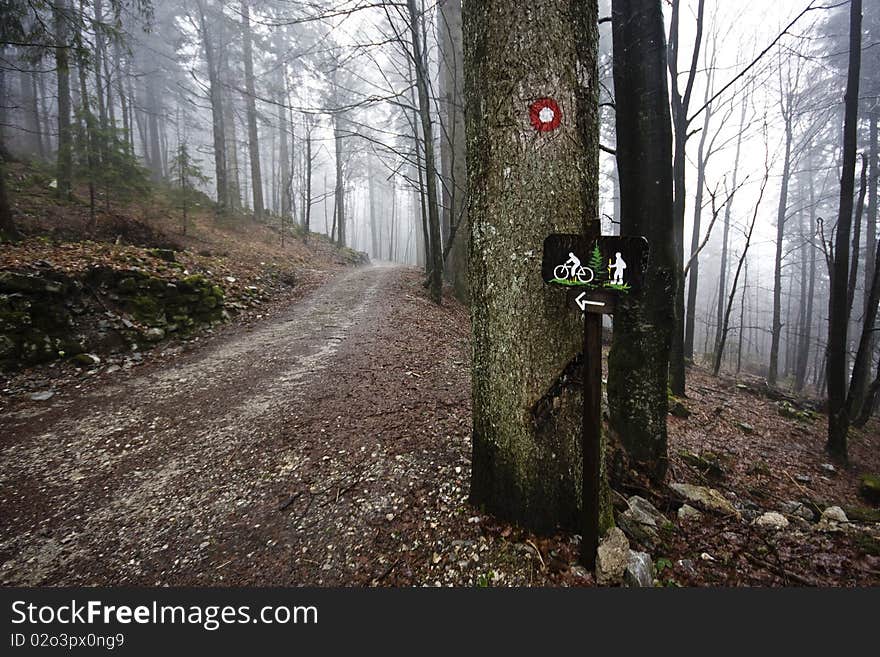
(463, 0, 612, 531)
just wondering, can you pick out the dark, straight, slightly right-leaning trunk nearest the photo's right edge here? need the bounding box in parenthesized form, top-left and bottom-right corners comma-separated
(825, 0, 862, 461)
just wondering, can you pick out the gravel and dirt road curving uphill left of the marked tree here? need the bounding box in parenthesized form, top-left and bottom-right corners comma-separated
(0, 266, 479, 586)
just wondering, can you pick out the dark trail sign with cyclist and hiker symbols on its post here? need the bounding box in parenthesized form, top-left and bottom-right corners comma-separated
(541, 235, 648, 570)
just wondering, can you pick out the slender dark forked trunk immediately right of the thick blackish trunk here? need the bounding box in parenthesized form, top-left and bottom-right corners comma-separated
(667, 0, 706, 396)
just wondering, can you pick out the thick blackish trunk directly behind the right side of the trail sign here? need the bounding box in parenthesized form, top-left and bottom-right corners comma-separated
(608, 0, 676, 481)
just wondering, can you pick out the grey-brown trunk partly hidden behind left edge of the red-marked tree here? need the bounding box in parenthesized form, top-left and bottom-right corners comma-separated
(438, 0, 468, 302)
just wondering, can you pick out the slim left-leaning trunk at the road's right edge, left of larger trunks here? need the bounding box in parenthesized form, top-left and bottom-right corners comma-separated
(407, 0, 443, 303)
